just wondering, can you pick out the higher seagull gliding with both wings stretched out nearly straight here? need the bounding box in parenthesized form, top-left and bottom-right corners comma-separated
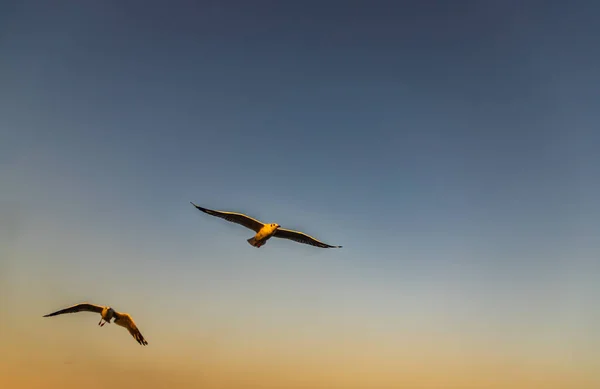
(190, 202, 342, 249)
